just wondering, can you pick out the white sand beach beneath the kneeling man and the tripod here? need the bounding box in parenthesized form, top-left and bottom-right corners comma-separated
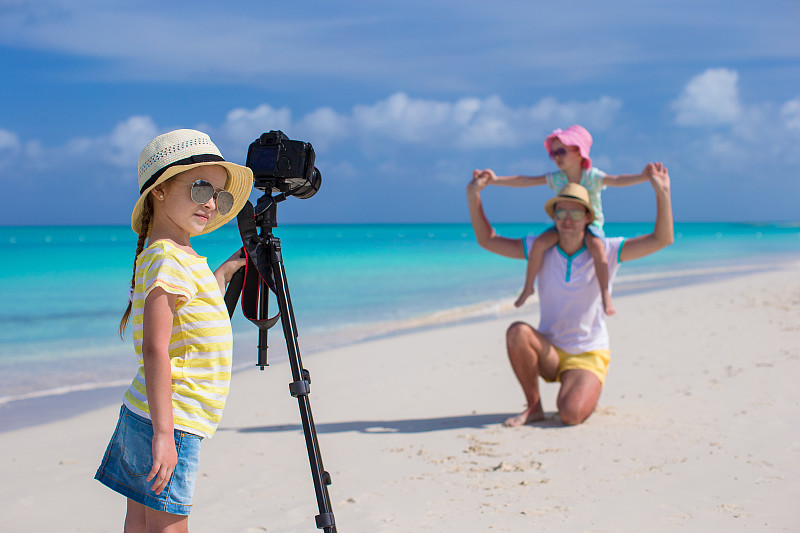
(0, 264, 800, 533)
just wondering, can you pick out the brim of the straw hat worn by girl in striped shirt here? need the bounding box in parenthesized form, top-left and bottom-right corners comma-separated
(131, 161, 253, 235)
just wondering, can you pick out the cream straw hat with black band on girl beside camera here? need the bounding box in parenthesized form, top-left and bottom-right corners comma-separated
(131, 130, 253, 233)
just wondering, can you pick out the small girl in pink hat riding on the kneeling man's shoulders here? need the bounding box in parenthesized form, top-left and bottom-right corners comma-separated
(483, 124, 647, 315)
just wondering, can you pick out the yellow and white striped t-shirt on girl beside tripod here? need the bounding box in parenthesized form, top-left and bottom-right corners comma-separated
(123, 241, 233, 437)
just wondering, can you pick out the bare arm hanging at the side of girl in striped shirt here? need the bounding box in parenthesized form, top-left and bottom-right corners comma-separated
(142, 287, 178, 494)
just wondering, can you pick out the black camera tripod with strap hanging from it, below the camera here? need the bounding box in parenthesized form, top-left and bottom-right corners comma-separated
(225, 193, 336, 533)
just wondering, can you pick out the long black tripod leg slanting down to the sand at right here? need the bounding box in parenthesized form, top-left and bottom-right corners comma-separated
(269, 235, 336, 533)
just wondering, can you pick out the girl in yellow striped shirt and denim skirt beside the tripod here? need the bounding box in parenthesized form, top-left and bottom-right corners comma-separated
(95, 130, 253, 532)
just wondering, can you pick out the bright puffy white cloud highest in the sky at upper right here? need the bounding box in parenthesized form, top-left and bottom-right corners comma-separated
(672, 68, 742, 126)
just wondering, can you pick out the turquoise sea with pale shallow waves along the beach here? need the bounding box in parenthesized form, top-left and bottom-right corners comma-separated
(0, 223, 800, 412)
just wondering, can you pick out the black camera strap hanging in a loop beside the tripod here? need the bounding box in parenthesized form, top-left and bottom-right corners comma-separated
(225, 201, 281, 331)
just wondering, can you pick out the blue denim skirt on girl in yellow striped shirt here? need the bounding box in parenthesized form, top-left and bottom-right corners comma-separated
(94, 405, 202, 515)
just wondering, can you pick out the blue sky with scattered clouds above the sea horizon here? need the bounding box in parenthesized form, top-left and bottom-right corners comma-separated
(0, 0, 800, 225)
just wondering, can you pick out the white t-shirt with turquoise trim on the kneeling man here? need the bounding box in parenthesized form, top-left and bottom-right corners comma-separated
(523, 236, 625, 354)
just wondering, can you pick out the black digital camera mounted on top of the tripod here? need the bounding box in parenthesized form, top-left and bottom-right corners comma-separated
(246, 130, 322, 199)
